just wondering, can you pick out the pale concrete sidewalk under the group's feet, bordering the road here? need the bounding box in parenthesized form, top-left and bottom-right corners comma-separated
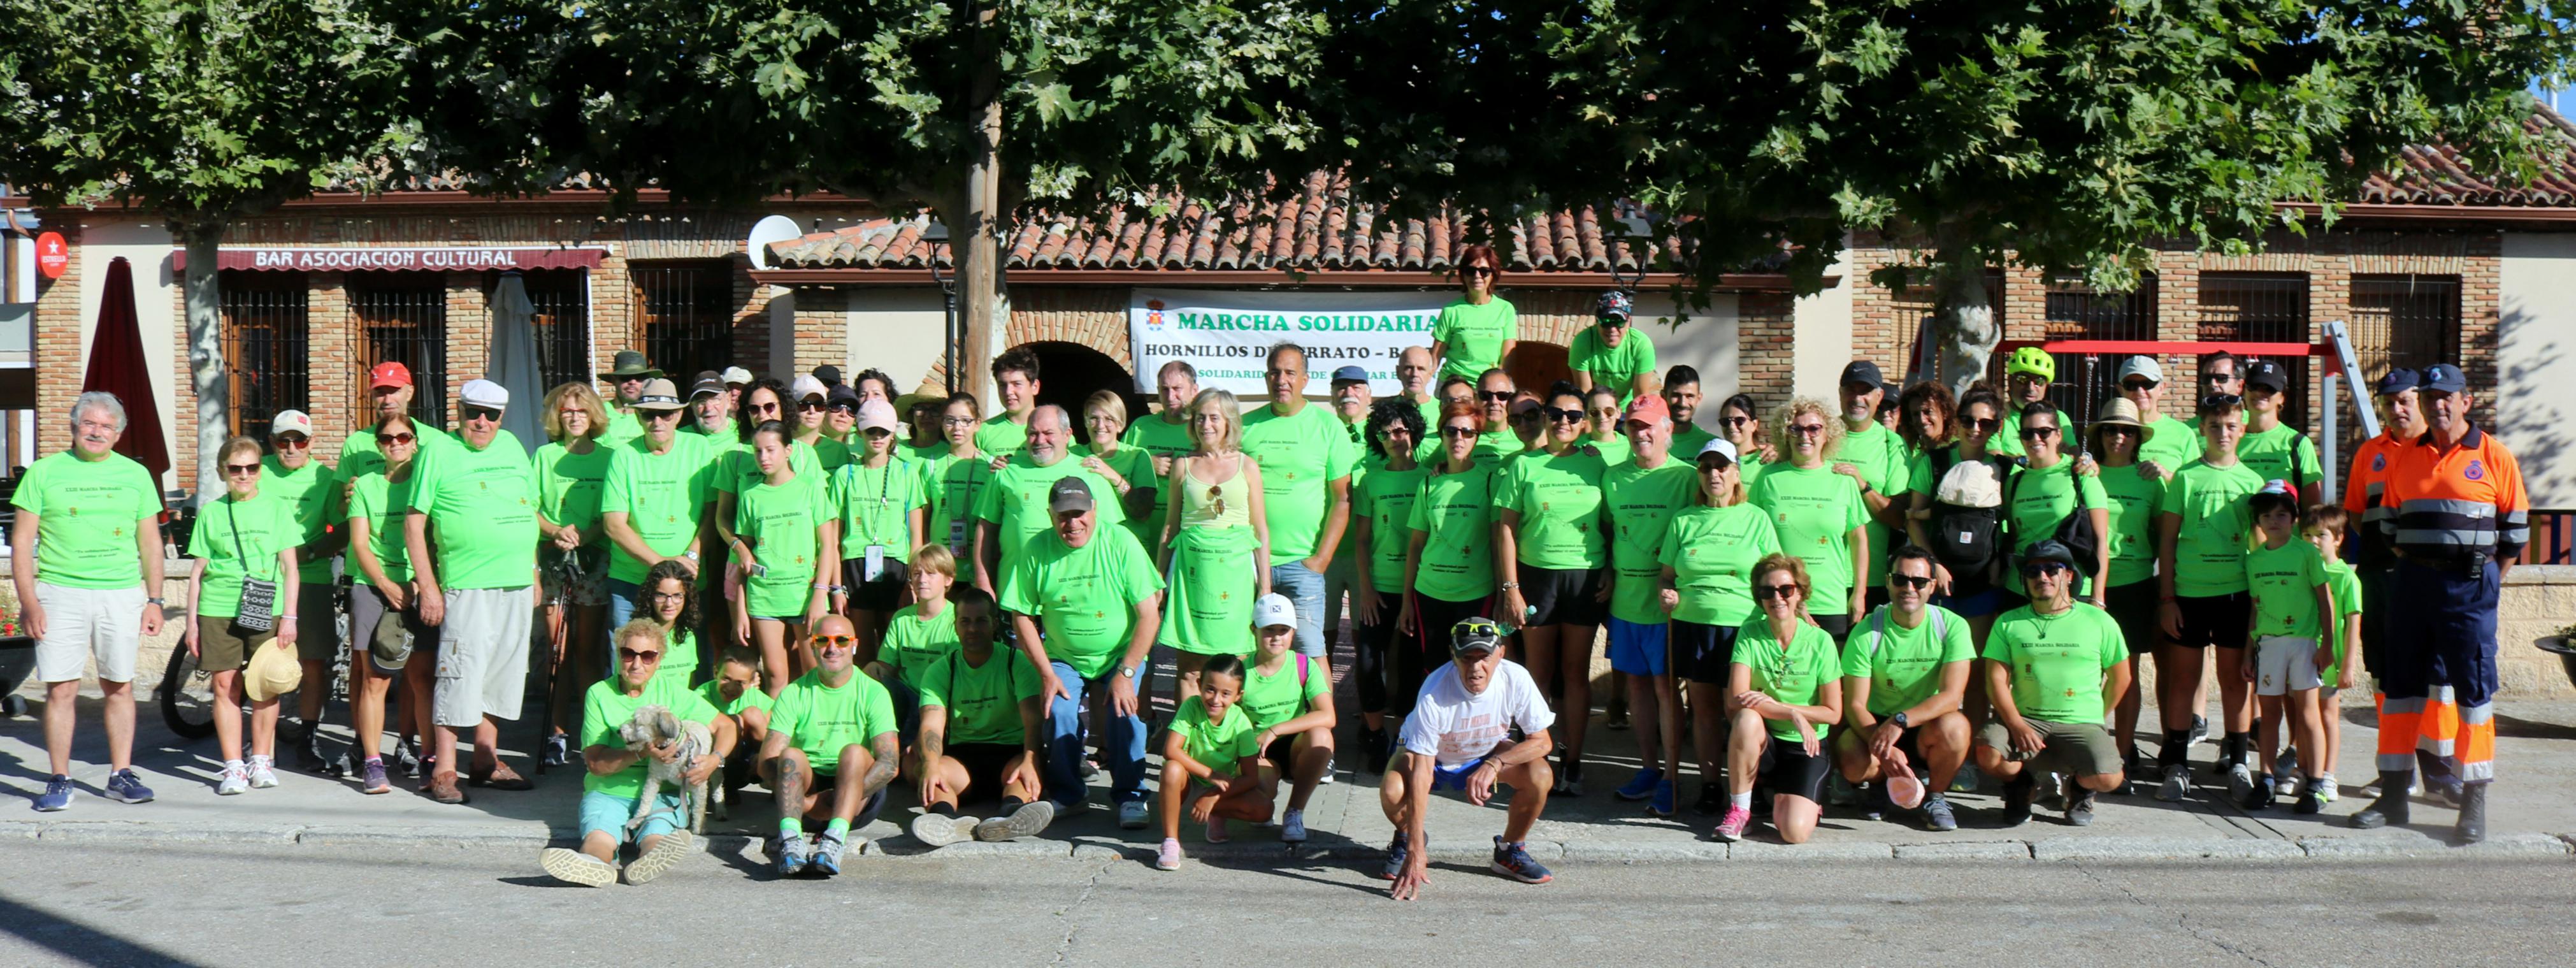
(0, 654, 2576, 862)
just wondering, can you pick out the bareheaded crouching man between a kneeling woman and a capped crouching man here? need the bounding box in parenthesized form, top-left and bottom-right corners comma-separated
(1834, 545, 1976, 832)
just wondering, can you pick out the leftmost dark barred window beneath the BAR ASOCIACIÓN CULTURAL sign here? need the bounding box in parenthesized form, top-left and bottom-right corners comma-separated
(217, 270, 312, 438)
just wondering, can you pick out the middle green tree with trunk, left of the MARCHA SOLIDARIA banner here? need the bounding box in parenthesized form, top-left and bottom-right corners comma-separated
(417, 0, 1324, 394)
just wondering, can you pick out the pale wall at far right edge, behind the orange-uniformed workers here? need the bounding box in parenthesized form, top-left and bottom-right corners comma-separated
(2494, 232, 2576, 510)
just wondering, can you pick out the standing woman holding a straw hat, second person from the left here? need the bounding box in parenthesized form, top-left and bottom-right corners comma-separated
(188, 438, 304, 795)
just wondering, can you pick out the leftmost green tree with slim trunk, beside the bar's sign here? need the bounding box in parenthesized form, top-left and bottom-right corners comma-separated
(0, 0, 410, 500)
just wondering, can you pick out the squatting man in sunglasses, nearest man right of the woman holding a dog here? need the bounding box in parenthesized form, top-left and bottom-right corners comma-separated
(760, 616, 902, 878)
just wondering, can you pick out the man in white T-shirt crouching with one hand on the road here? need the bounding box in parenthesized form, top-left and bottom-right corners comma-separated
(1378, 618, 1556, 901)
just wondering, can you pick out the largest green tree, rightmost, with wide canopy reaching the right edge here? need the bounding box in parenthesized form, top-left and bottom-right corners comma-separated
(1311, 0, 2576, 386)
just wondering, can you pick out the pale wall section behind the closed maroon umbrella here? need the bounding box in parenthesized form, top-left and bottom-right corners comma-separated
(75, 213, 180, 489)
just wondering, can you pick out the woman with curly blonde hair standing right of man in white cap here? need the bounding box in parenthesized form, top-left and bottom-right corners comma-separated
(536, 384, 615, 770)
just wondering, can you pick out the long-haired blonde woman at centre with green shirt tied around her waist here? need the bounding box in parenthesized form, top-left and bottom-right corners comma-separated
(1159, 389, 1270, 703)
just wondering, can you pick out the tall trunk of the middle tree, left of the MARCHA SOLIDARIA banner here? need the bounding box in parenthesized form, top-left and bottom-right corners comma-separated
(948, 3, 1002, 396)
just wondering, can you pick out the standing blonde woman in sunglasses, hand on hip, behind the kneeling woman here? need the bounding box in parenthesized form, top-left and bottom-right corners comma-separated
(1746, 396, 1870, 641)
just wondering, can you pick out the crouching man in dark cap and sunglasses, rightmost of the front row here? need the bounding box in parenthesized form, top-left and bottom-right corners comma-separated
(1976, 540, 2131, 827)
